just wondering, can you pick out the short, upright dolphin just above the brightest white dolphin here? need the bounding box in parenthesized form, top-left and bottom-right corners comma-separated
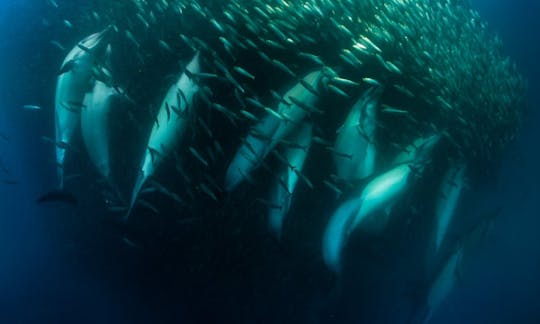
(333, 86, 382, 181)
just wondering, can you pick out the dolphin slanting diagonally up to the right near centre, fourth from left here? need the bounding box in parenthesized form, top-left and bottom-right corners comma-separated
(225, 70, 322, 192)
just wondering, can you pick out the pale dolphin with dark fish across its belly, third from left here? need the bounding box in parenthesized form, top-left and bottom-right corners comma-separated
(126, 52, 201, 220)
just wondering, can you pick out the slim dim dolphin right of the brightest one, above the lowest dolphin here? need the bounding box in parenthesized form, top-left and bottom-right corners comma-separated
(434, 162, 466, 253)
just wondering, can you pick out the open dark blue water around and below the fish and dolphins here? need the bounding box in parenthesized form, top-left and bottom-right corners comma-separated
(0, 0, 540, 323)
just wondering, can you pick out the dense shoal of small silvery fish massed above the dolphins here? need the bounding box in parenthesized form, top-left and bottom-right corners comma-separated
(82, 0, 525, 163)
